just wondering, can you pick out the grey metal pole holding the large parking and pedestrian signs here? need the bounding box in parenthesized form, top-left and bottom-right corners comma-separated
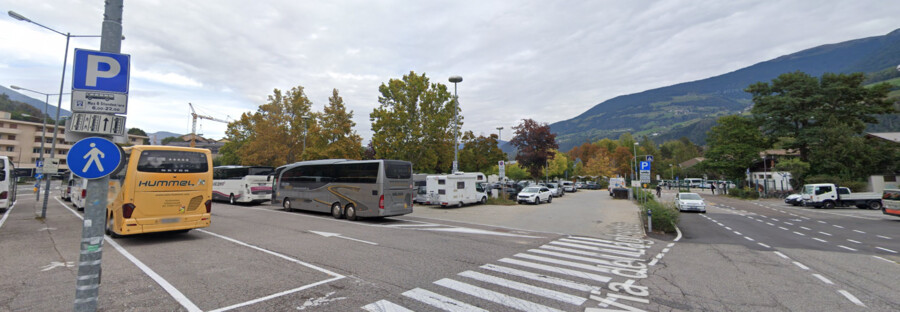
(70, 0, 123, 312)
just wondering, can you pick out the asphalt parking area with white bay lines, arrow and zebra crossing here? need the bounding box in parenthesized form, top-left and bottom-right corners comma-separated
(0, 184, 658, 311)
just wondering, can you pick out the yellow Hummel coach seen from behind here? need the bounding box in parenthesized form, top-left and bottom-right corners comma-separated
(106, 145, 213, 237)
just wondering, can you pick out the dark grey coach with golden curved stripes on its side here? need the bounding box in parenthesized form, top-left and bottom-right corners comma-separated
(272, 159, 415, 220)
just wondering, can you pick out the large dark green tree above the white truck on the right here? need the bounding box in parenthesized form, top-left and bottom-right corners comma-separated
(746, 71, 893, 162)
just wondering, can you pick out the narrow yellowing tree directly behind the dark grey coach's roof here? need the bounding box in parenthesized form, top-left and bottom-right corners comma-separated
(319, 89, 363, 159)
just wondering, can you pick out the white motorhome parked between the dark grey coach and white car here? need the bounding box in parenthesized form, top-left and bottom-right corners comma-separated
(425, 172, 487, 207)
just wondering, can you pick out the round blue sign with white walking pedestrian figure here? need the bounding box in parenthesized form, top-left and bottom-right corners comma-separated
(66, 137, 122, 179)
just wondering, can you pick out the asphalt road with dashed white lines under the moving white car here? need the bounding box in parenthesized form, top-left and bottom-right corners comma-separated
(647, 194, 900, 311)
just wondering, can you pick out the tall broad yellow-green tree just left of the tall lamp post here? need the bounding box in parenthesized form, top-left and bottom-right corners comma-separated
(369, 72, 462, 172)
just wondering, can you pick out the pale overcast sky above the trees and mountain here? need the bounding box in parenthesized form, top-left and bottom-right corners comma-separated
(0, 0, 900, 141)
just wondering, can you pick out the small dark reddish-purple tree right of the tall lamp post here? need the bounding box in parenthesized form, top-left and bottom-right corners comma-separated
(509, 119, 559, 180)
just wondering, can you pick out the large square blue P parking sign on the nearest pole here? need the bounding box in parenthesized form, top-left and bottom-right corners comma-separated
(72, 49, 131, 94)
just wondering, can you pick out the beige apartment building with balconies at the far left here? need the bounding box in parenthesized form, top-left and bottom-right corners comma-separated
(0, 111, 149, 170)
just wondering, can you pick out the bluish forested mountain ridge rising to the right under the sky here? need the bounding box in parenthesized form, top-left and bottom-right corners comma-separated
(550, 29, 900, 151)
